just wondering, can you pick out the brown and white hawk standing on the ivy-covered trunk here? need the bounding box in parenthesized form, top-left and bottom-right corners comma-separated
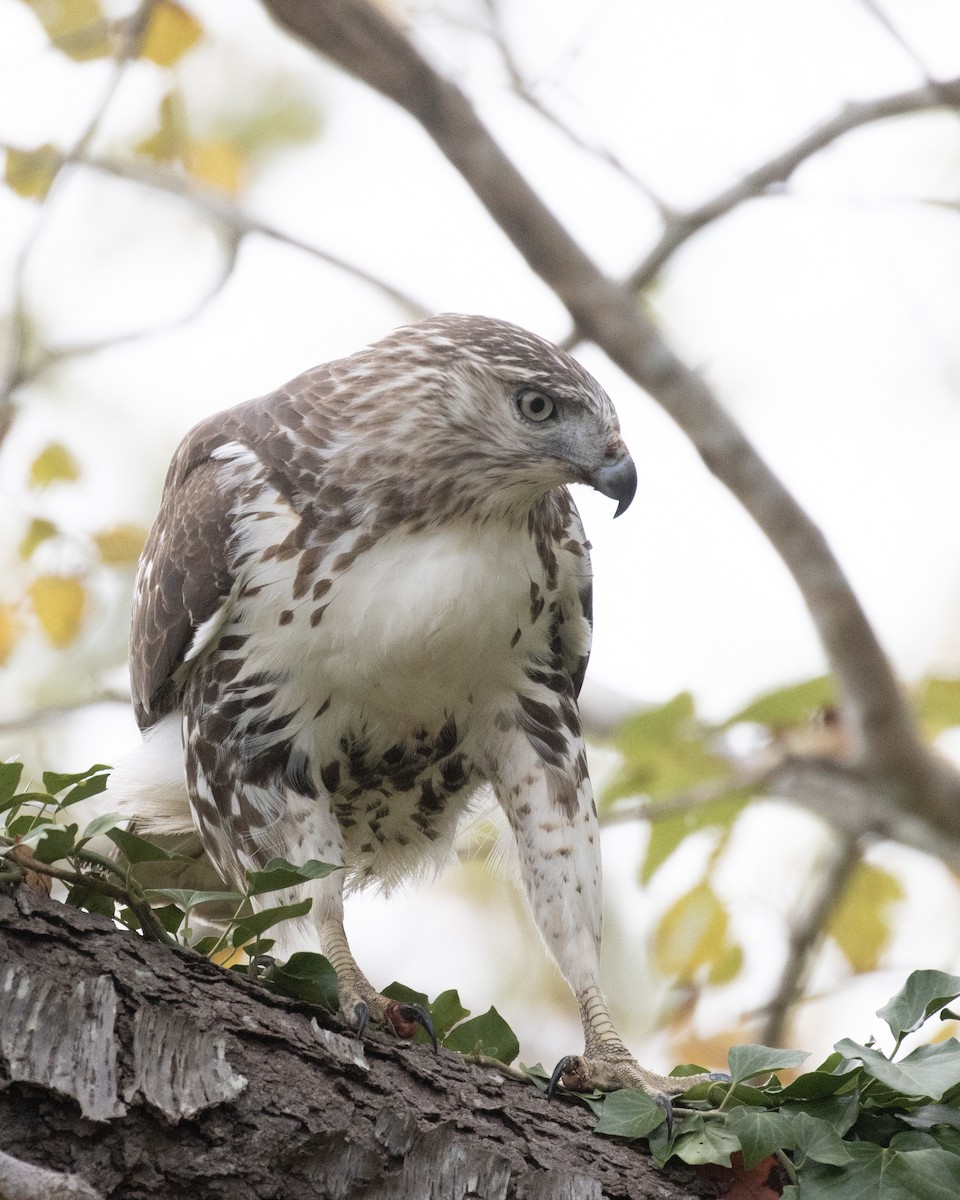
(112, 314, 703, 1097)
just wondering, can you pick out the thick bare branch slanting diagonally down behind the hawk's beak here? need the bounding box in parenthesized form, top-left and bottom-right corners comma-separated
(264, 0, 960, 832)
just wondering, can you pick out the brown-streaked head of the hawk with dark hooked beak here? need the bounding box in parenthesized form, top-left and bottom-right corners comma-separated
(324, 313, 637, 525)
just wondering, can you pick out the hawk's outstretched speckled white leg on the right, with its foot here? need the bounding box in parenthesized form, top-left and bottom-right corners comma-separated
(492, 709, 714, 1112)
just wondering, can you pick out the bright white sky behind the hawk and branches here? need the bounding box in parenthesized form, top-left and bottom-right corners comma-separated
(0, 0, 960, 1057)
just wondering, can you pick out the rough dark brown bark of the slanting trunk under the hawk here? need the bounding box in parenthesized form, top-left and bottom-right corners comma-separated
(0, 887, 716, 1200)
